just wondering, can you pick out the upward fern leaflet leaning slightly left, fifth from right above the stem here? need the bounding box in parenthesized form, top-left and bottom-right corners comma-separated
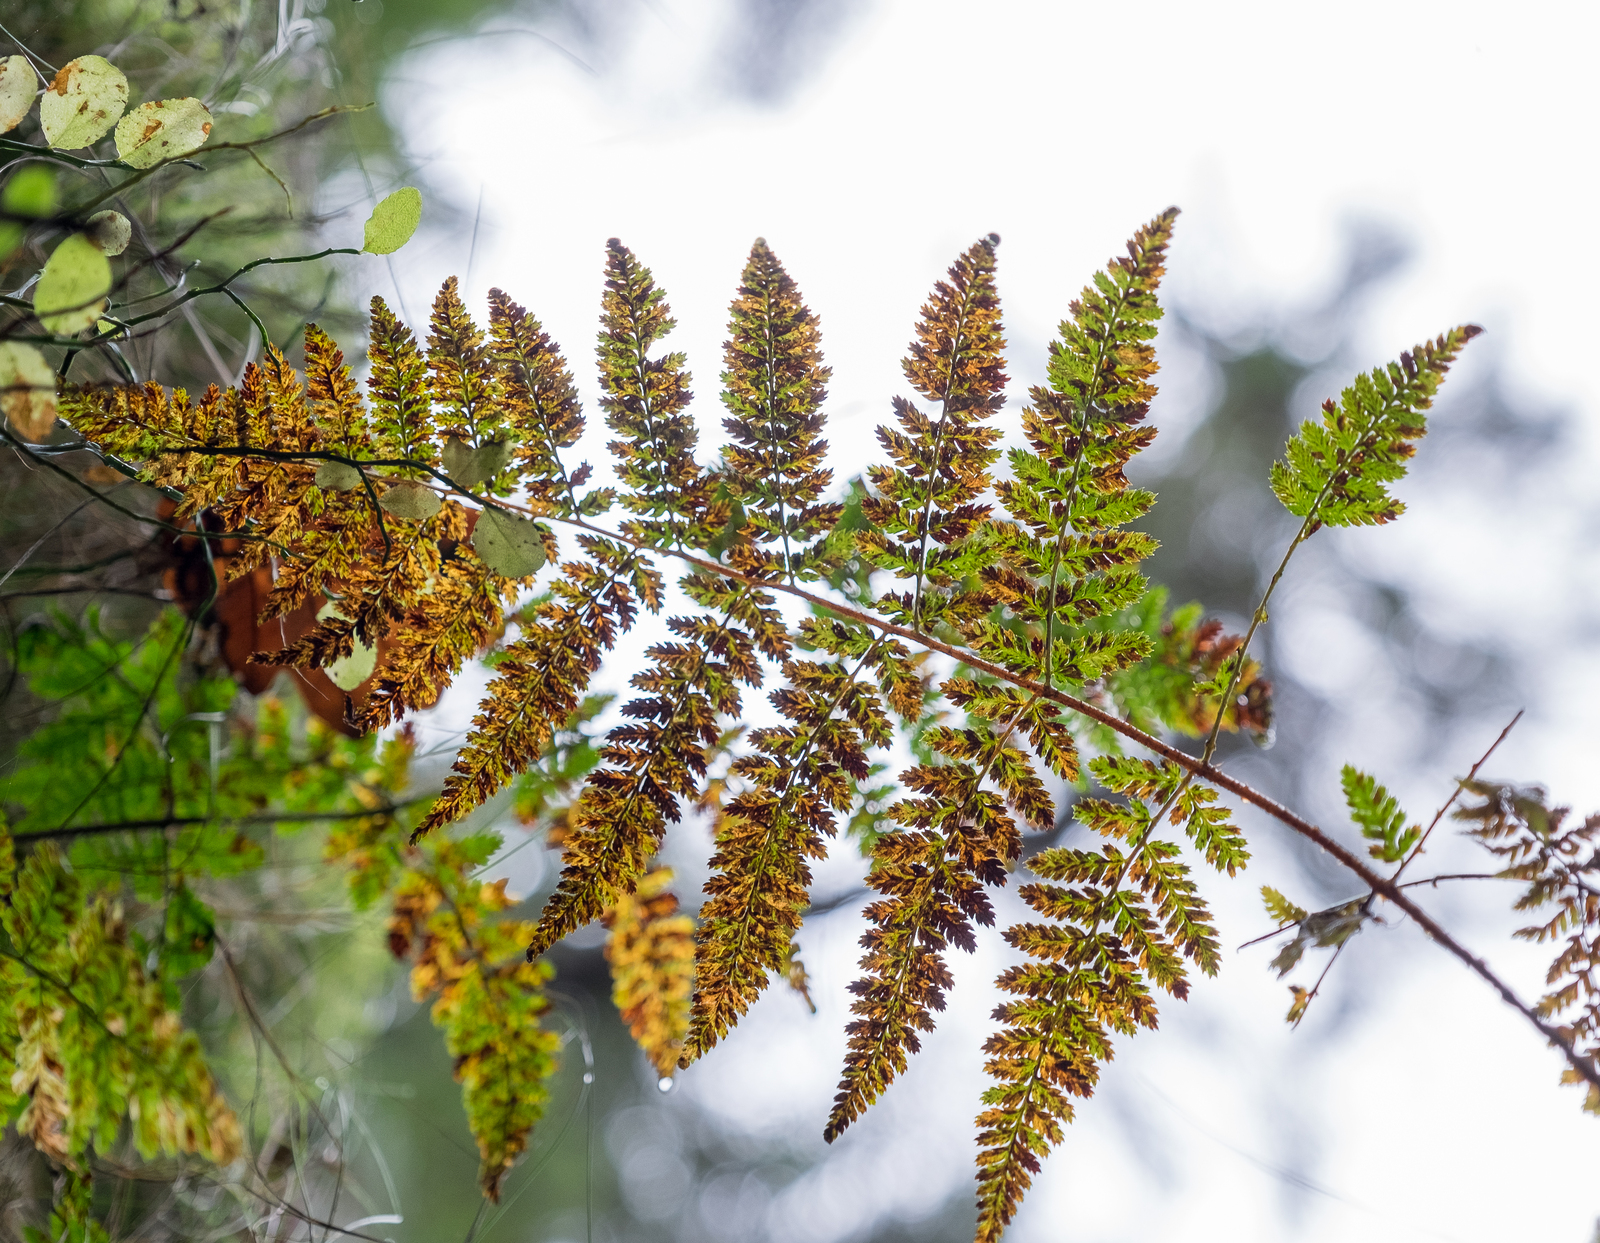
(597, 237, 710, 547)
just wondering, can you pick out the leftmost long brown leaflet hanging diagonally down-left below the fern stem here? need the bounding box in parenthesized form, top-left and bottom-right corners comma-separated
(411, 536, 661, 841)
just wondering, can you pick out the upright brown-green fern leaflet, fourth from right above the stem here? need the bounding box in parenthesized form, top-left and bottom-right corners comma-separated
(722, 238, 843, 581)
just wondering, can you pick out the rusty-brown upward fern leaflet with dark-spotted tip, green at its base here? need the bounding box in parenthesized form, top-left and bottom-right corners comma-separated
(856, 234, 1006, 630)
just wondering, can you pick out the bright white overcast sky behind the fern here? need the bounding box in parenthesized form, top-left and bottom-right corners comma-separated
(368, 0, 1600, 1243)
